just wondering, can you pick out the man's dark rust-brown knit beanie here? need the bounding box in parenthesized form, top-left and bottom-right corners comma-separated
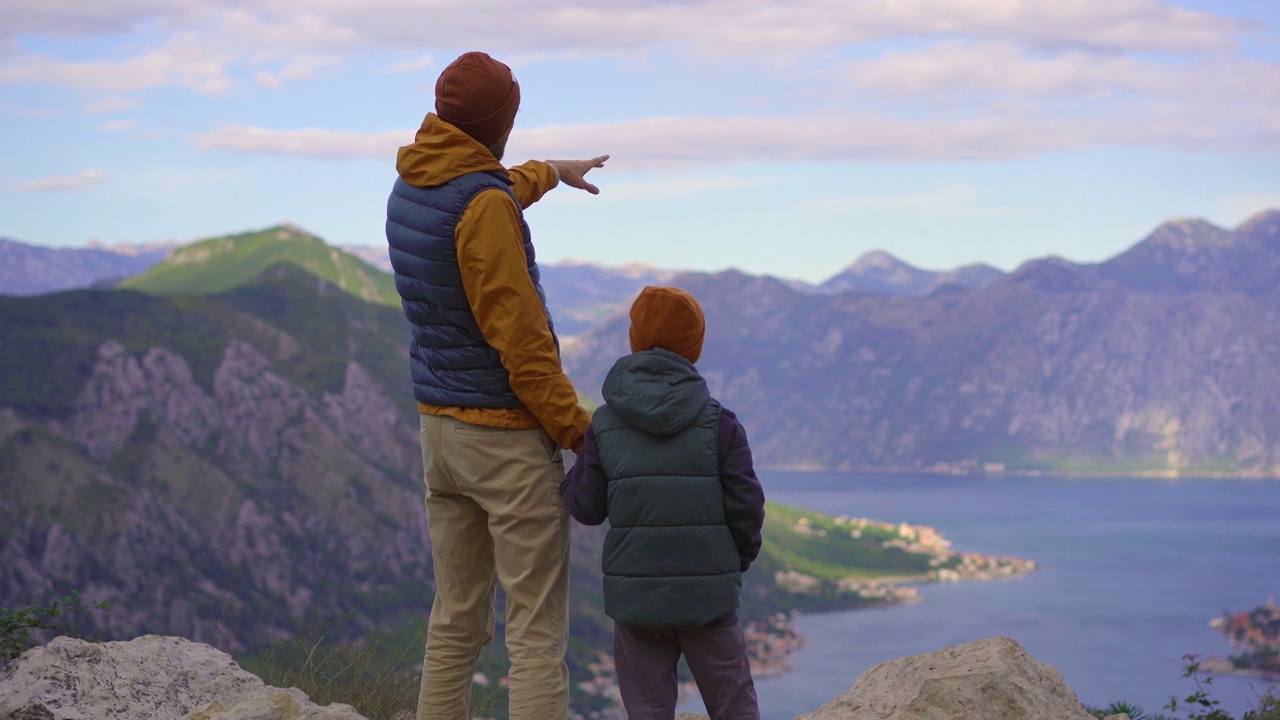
(435, 53, 520, 146)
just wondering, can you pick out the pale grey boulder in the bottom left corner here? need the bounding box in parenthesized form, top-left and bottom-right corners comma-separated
(0, 635, 365, 720)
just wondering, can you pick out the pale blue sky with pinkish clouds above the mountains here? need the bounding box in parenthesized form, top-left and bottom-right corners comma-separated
(0, 0, 1280, 282)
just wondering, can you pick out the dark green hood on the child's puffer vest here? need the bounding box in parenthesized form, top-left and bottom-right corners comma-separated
(602, 347, 712, 436)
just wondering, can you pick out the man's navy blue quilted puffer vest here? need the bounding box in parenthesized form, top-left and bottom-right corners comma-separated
(387, 172, 559, 407)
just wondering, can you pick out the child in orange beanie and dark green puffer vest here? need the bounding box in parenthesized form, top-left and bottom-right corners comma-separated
(561, 287, 764, 720)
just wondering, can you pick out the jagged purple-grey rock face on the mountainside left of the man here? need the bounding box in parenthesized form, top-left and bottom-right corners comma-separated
(0, 294, 431, 648)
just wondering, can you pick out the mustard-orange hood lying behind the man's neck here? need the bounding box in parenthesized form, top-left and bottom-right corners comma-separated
(396, 113, 507, 187)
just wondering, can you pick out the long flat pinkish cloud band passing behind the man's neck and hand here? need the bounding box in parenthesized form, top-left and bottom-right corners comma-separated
(192, 105, 1280, 172)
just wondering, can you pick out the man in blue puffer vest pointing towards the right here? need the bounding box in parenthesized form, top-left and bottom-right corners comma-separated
(387, 53, 608, 720)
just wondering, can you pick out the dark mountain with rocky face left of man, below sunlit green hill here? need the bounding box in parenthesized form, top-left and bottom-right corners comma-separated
(0, 265, 431, 648)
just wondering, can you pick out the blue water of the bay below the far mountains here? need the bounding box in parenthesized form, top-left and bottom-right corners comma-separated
(681, 471, 1280, 720)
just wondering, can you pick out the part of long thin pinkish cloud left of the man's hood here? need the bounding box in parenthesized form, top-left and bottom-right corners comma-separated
(192, 123, 413, 159)
